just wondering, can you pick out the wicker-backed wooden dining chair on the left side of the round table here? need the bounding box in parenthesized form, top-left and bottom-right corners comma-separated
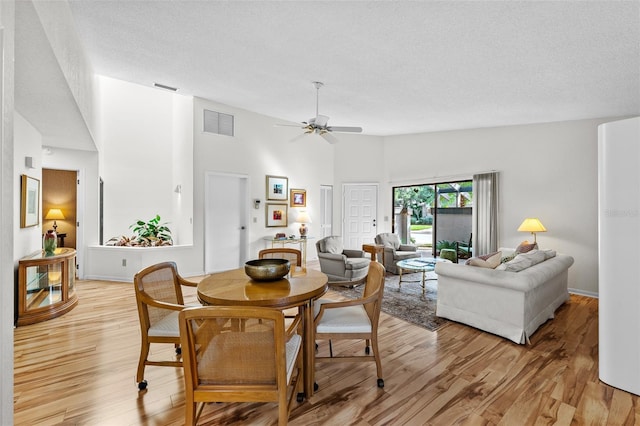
(133, 262, 197, 390)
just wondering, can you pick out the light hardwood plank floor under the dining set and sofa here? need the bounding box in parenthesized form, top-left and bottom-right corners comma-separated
(14, 266, 640, 426)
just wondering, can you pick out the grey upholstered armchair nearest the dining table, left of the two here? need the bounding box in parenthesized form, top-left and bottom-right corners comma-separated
(316, 236, 371, 282)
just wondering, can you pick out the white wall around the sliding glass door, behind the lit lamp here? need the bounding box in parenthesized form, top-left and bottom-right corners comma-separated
(364, 119, 610, 294)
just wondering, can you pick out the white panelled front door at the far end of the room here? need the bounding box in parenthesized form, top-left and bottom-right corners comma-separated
(342, 184, 378, 249)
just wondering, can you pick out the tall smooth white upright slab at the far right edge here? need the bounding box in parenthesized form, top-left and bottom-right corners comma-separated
(598, 117, 640, 395)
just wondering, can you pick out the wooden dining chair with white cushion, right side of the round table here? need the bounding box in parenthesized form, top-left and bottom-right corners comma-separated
(314, 262, 385, 387)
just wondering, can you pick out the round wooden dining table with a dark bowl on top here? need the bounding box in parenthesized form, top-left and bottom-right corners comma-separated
(198, 266, 328, 397)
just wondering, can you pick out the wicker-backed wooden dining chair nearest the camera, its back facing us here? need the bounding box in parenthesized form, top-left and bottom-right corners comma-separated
(179, 306, 303, 425)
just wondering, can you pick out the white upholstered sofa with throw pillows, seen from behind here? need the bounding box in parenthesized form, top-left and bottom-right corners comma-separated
(435, 248, 573, 344)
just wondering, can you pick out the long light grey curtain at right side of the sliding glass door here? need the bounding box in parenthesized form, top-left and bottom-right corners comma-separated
(472, 172, 498, 256)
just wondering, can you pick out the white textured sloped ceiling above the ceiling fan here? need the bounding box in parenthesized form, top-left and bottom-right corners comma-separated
(69, 0, 640, 135)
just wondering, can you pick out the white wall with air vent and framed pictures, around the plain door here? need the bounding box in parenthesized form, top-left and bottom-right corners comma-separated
(193, 98, 334, 260)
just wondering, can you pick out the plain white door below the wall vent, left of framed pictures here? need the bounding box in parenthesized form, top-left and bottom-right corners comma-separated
(204, 173, 248, 273)
